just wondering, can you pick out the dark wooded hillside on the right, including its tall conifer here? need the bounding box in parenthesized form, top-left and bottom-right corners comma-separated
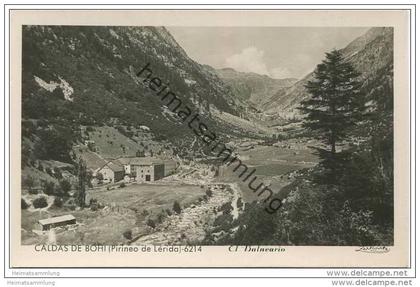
(206, 28, 394, 246)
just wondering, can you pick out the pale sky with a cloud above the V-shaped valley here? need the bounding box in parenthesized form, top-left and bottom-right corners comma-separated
(166, 27, 369, 79)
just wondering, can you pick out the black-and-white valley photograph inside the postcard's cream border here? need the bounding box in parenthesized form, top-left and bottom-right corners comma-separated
(21, 26, 394, 246)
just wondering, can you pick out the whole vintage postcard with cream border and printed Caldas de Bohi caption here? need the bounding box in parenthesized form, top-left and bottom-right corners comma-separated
(10, 10, 410, 268)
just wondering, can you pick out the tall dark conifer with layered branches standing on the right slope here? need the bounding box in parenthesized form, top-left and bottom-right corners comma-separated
(300, 50, 365, 180)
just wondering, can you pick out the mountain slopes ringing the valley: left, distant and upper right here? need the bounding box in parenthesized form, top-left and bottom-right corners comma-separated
(22, 26, 393, 165)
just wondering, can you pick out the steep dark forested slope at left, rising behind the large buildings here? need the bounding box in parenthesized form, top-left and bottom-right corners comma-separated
(22, 26, 248, 165)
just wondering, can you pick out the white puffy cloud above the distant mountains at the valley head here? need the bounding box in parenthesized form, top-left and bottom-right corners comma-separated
(226, 46, 290, 79)
